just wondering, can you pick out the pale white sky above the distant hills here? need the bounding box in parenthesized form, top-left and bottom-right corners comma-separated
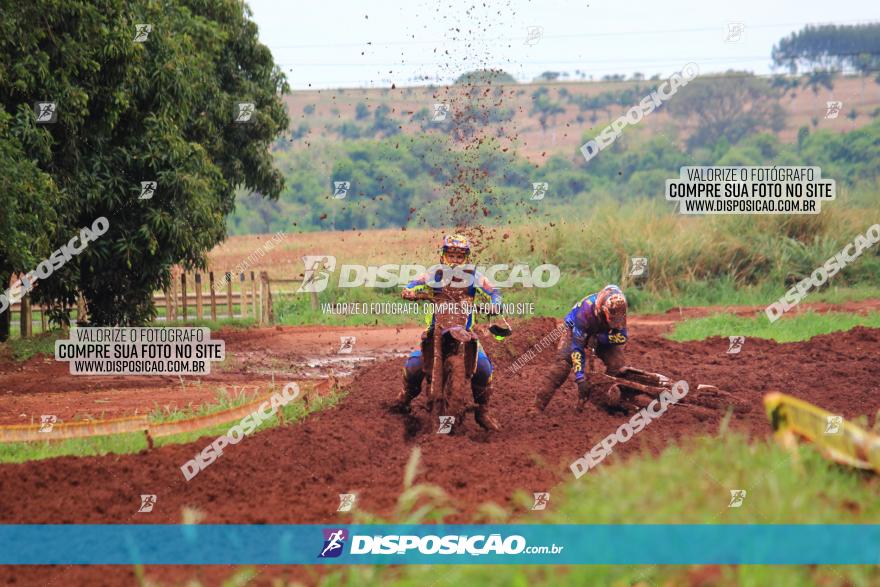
(248, 0, 880, 90)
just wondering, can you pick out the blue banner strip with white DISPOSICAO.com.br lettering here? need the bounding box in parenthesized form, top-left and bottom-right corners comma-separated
(0, 524, 880, 565)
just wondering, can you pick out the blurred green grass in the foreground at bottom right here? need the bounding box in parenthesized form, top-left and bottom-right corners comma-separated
(320, 432, 880, 587)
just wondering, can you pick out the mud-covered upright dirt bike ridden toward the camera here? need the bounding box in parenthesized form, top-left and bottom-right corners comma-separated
(409, 285, 512, 433)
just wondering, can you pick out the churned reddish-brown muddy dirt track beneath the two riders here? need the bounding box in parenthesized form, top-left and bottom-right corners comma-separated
(0, 318, 880, 582)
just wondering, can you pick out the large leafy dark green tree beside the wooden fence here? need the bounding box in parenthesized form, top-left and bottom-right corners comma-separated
(0, 0, 288, 324)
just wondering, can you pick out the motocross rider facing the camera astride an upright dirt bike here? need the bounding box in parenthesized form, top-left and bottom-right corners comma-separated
(394, 234, 501, 431)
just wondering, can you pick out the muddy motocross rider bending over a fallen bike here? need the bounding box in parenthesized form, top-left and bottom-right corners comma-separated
(532, 285, 627, 412)
